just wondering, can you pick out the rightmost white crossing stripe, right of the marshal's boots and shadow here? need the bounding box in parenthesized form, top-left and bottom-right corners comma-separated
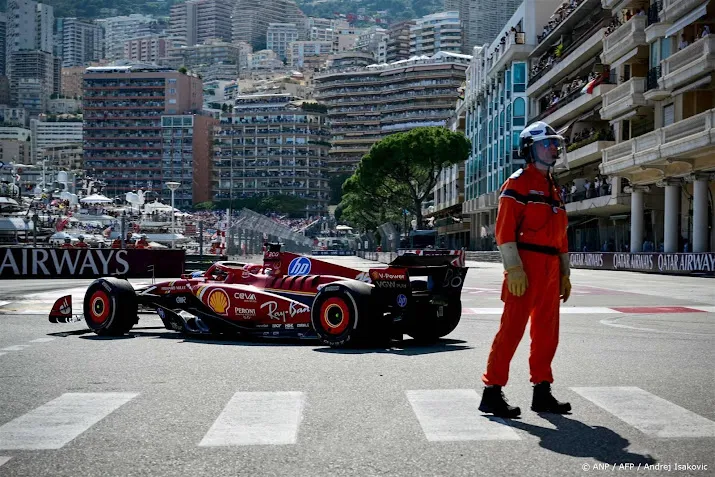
(571, 386, 715, 437)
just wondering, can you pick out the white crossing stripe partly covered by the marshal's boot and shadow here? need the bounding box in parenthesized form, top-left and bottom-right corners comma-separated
(407, 389, 521, 442)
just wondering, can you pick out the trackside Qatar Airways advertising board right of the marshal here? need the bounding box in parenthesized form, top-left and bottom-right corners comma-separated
(569, 252, 715, 276)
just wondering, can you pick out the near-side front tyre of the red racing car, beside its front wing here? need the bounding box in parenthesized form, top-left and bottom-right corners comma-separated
(84, 277, 139, 336)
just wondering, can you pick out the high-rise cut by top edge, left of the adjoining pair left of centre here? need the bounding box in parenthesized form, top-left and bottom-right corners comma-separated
(168, 0, 233, 46)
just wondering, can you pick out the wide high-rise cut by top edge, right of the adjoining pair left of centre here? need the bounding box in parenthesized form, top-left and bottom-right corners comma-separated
(232, 0, 306, 51)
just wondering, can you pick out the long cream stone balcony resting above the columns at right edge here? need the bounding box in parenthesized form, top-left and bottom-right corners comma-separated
(601, 109, 715, 178)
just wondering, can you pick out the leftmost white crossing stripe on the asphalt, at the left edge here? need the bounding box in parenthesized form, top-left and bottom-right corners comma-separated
(0, 393, 138, 450)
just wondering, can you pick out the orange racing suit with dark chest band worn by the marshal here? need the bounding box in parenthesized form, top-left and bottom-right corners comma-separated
(482, 164, 568, 386)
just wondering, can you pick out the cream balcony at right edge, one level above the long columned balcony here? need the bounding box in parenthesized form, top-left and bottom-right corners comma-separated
(658, 35, 715, 90)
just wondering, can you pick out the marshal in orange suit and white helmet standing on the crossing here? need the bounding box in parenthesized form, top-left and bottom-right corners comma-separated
(479, 122, 571, 418)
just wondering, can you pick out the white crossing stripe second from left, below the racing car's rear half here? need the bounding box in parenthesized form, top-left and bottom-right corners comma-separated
(199, 391, 305, 447)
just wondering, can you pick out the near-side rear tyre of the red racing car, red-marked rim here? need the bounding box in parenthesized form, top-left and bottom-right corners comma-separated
(310, 287, 364, 348)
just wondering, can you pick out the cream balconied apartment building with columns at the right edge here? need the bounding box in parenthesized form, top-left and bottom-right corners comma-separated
(600, 0, 715, 252)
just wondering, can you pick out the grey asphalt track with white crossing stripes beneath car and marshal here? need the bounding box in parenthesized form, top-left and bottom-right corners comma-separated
(0, 257, 715, 476)
